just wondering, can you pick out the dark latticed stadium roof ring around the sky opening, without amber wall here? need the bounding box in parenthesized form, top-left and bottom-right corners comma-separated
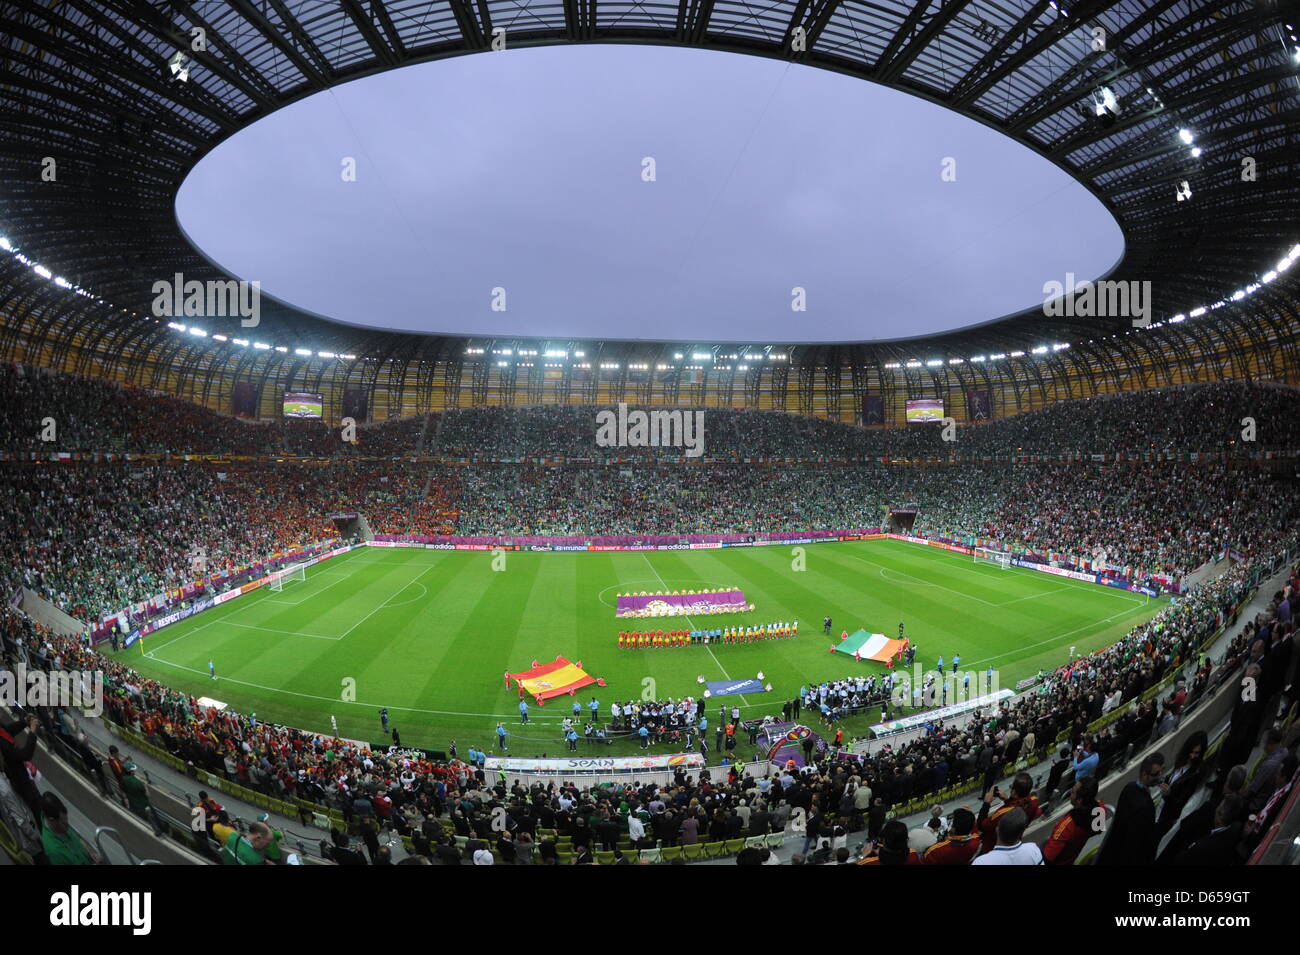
(0, 0, 1300, 376)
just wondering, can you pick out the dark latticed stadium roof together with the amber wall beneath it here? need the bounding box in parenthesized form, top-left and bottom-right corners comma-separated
(0, 0, 1300, 425)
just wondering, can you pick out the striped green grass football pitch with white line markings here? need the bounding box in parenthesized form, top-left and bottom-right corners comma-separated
(118, 541, 1165, 756)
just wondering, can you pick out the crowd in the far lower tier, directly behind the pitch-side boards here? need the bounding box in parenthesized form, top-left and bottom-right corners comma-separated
(0, 461, 1296, 628)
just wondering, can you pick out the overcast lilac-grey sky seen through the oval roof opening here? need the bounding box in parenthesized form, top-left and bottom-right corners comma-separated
(177, 45, 1123, 343)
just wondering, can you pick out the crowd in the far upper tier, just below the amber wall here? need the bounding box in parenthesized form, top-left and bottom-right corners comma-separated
(10, 364, 1300, 463)
